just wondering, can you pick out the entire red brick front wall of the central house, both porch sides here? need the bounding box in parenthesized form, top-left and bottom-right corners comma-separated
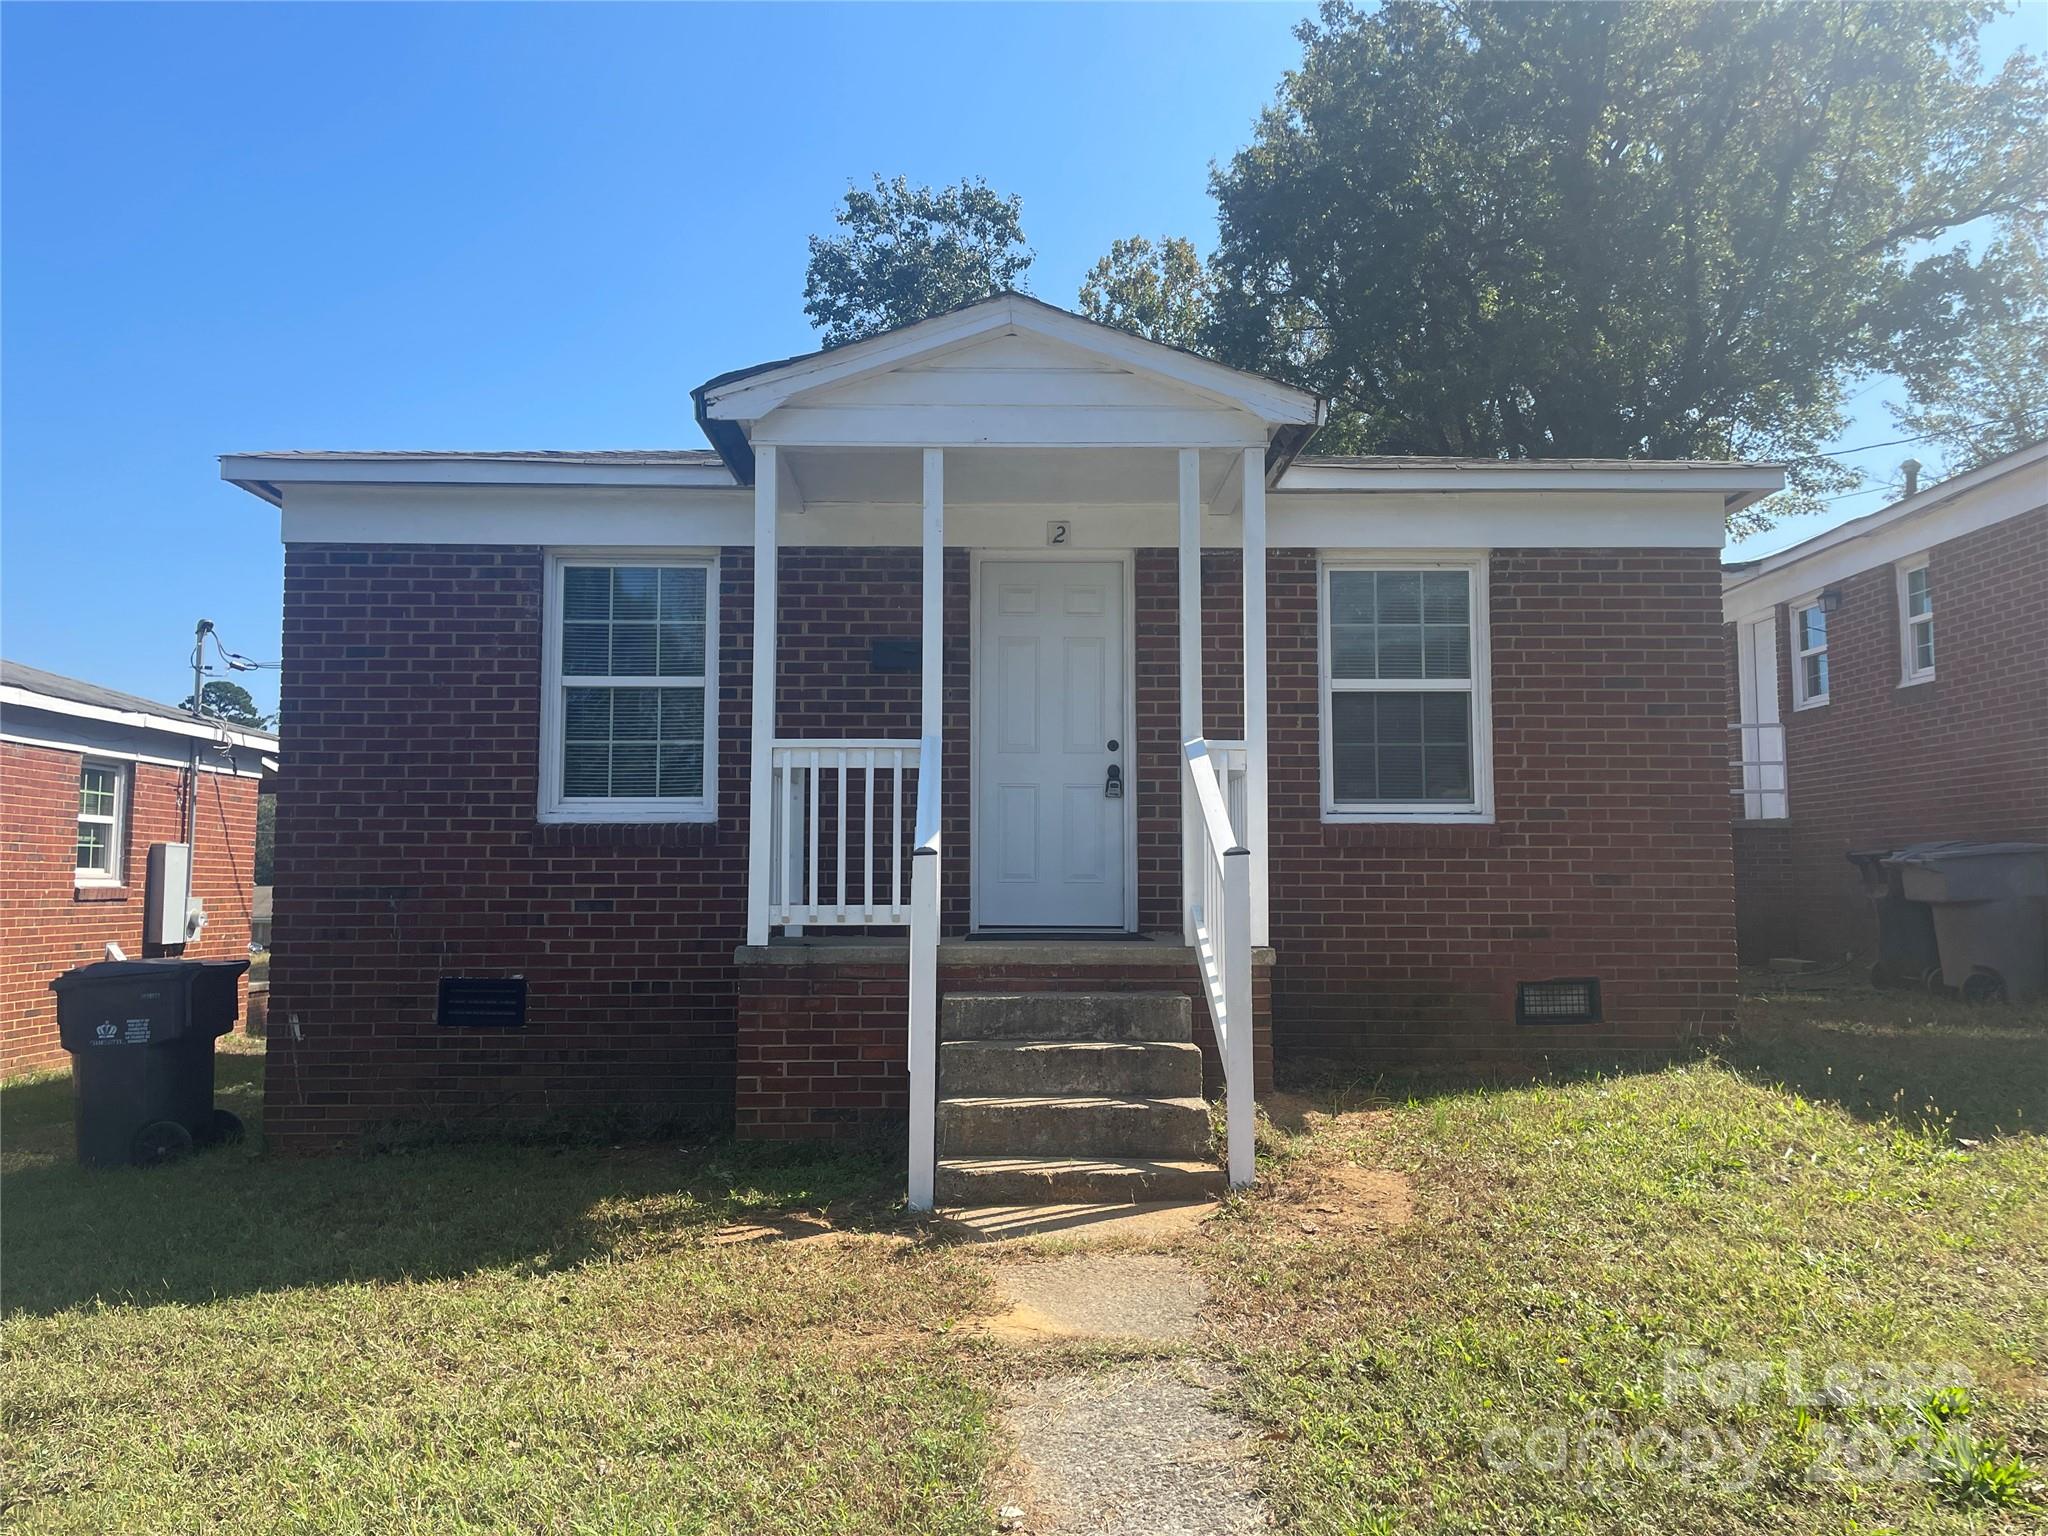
(268, 547, 1733, 1147)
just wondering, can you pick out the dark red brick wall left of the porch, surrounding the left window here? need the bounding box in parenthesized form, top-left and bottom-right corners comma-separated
(264, 545, 754, 1151)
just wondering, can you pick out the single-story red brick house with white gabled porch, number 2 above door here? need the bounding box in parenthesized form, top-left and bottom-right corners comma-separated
(221, 295, 1780, 1204)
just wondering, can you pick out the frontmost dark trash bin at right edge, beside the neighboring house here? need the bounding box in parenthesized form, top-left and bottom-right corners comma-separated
(1884, 842, 2048, 1001)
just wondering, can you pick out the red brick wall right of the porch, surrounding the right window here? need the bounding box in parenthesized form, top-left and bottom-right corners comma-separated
(1268, 549, 1735, 1063)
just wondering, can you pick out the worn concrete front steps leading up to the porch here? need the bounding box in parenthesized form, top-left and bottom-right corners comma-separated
(936, 991, 1223, 1206)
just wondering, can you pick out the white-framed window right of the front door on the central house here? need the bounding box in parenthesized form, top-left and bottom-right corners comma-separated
(1319, 559, 1493, 821)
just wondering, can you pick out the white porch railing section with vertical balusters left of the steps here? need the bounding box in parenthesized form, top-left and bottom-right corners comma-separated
(768, 741, 938, 928)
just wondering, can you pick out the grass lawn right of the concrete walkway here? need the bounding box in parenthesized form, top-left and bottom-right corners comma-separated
(1206, 993, 2048, 1536)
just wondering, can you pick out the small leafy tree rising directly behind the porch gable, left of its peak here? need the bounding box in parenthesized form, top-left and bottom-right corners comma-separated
(803, 176, 1032, 346)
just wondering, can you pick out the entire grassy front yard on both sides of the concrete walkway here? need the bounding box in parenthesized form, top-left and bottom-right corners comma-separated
(0, 993, 2048, 1534)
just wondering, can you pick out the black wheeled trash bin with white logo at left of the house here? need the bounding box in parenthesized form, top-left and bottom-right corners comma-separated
(49, 961, 250, 1167)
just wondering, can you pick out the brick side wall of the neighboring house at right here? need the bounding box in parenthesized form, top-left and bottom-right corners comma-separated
(1729, 508, 2048, 961)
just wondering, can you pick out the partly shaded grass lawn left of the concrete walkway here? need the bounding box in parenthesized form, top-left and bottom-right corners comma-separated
(0, 1040, 991, 1536)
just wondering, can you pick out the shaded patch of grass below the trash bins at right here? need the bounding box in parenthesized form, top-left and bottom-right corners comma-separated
(1716, 987, 2048, 1137)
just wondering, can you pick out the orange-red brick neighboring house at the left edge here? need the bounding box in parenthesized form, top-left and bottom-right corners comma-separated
(0, 662, 276, 1073)
